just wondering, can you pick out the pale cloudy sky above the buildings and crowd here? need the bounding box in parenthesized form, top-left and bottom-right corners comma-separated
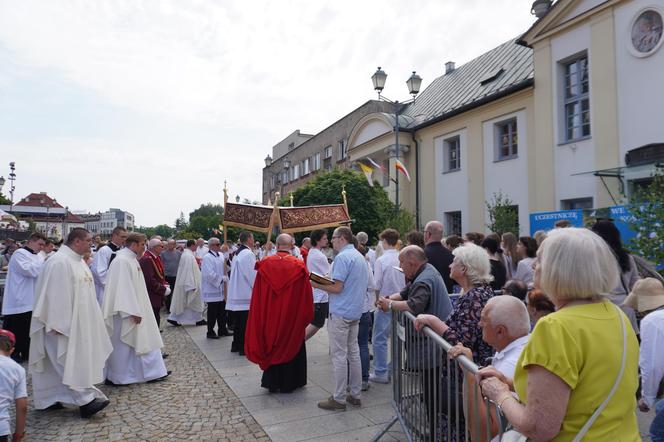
(0, 0, 535, 226)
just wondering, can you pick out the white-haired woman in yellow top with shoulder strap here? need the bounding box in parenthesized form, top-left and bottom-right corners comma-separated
(478, 228, 640, 441)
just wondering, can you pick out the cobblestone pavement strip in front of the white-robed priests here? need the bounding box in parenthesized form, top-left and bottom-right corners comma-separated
(26, 326, 270, 441)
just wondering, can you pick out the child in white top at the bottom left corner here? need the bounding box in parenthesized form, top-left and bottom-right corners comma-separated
(0, 329, 28, 442)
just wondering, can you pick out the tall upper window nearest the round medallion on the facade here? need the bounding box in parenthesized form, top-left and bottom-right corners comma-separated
(564, 56, 590, 141)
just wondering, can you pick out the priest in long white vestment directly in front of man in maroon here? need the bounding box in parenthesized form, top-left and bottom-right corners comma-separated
(102, 233, 169, 385)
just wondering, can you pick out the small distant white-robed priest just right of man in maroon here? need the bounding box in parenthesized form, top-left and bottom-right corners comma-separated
(168, 239, 207, 326)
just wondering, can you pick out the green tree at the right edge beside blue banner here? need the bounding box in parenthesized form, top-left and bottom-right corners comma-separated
(628, 174, 664, 269)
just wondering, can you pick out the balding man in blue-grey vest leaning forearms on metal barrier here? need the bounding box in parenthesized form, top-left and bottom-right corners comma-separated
(377, 245, 452, 434)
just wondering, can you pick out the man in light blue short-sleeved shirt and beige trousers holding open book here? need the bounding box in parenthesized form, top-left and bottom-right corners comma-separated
(311, 227, 369, 411)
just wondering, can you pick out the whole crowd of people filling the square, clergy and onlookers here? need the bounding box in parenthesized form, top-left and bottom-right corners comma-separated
(0, 216, 664, 440)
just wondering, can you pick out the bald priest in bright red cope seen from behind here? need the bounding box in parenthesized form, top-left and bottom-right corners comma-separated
(245, 234, 314, 393)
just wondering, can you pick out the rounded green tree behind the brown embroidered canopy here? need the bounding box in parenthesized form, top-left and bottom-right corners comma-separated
(282, 169, 394, 239)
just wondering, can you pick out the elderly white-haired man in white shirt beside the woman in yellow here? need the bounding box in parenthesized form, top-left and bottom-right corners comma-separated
(448, 296, 530, 440)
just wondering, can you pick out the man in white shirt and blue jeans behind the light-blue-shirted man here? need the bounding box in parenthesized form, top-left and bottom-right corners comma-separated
(369, 229, 406, 384)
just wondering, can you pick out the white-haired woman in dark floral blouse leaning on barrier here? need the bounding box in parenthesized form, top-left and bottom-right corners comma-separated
(415, 242, 493, 365)
